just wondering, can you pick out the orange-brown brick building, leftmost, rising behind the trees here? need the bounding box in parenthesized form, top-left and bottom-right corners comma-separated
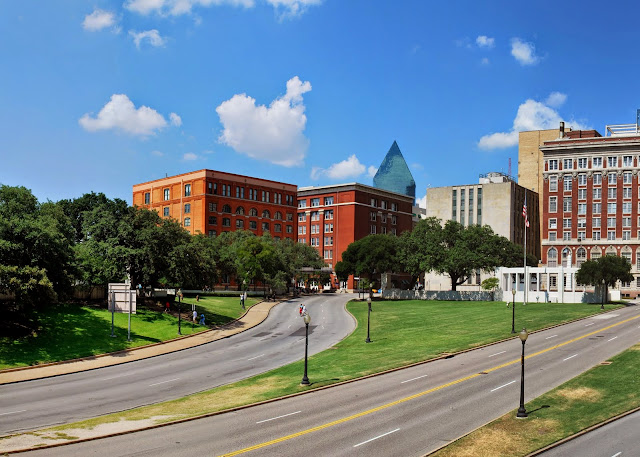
(133, 170, 297, 240)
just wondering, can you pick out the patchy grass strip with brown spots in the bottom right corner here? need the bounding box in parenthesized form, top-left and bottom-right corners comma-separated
(434, 345, 640, 457)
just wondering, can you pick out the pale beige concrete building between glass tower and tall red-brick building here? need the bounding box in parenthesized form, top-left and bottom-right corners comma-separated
(425, 173, 542, 290)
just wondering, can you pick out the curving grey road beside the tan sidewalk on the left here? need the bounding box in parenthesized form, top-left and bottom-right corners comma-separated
(0, 294, 355, 434)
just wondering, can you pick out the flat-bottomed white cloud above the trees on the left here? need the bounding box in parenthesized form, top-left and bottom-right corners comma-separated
(78, 94, 167, 136)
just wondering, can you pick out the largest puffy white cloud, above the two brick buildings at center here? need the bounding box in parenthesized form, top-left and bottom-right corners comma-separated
(216, 76, 311, 167)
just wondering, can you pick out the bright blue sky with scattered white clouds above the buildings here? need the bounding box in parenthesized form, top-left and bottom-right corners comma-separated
(0, 0, 640, 208)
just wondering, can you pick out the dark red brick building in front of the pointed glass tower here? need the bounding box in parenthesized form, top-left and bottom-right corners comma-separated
(297, 183, 413, 289)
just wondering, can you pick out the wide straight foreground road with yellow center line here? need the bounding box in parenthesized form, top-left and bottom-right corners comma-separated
(20, 306, 640, 457)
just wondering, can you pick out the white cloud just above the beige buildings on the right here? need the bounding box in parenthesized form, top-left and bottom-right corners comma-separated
(478, 92, 588, 150)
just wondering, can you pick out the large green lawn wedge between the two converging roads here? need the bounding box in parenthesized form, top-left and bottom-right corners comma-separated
(51, 301, 617, 426)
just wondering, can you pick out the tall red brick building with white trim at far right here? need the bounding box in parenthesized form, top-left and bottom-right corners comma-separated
(540, 124, 640, 297)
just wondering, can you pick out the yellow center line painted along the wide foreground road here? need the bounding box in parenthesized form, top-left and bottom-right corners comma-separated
(221, 316, 640, 457)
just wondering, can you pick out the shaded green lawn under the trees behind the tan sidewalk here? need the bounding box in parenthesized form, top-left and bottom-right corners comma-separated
(0, 297, 258, 369)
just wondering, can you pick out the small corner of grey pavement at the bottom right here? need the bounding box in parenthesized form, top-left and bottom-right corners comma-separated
(541, 412, 640, 457)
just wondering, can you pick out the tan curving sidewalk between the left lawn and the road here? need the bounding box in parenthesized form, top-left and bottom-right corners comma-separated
(0, 301, 281, 385)
